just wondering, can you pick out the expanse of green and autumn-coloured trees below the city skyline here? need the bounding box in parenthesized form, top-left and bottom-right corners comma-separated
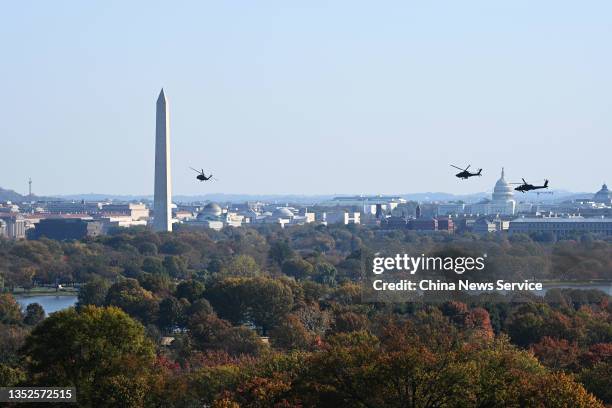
(0, 226, 612, 407)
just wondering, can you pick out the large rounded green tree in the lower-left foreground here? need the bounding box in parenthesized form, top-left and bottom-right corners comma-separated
(22, 306, 154, 407)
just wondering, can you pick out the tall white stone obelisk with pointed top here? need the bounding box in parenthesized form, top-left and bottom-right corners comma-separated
(153, 88, 172, 231)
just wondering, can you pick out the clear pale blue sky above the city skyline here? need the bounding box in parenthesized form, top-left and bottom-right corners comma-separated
(0, 0, 612, 194)
